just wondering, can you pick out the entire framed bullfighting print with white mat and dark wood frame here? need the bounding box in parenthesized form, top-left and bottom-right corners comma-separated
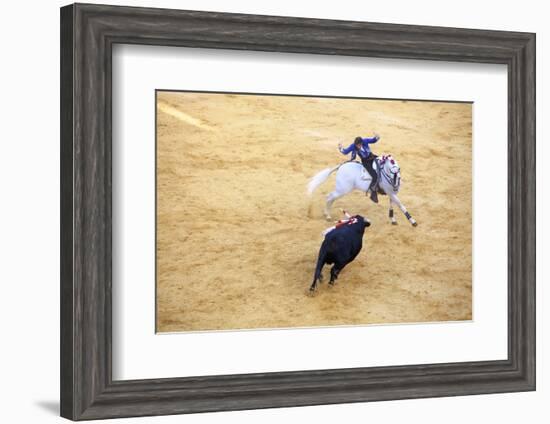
(61, 4, 535, 420)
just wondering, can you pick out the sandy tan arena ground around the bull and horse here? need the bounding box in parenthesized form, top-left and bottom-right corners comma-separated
(157, 92, 472, 332)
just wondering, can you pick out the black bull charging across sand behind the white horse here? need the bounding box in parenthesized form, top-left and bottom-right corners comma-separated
(309, 215, 370, 292)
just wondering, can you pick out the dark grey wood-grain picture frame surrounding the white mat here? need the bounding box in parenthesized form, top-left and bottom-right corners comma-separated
(60, 4, 535, 420)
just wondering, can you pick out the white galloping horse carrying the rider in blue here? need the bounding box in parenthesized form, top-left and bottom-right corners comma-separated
(307, 155, 417, 227)
